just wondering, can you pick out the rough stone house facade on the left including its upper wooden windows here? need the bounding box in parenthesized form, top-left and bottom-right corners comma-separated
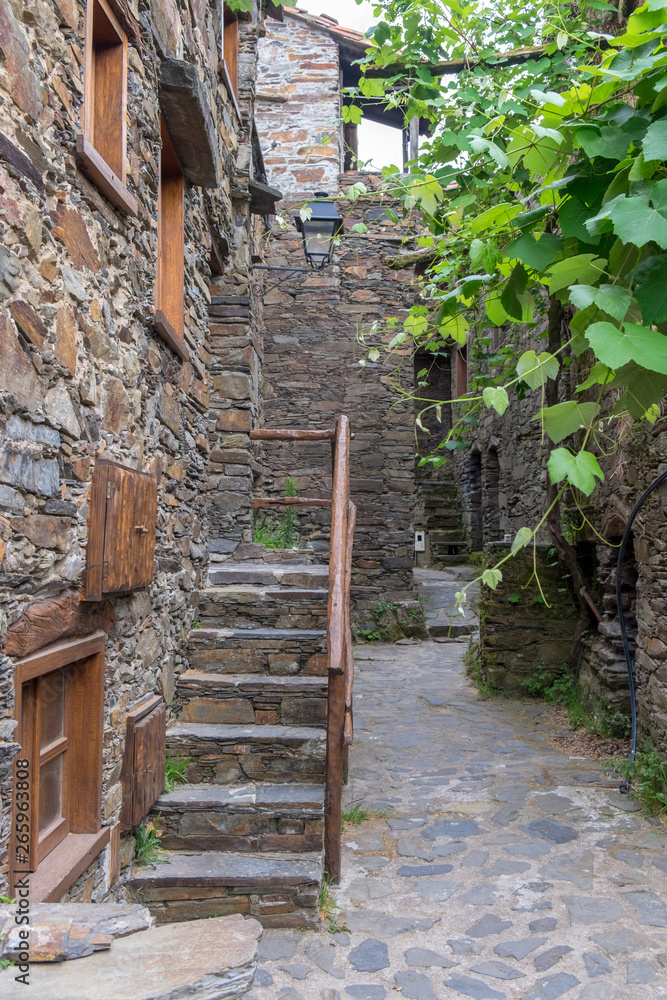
(0, 0, 276, 901)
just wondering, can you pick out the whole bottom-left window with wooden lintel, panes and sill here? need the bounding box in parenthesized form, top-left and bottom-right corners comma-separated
(10, 632, 110, 902)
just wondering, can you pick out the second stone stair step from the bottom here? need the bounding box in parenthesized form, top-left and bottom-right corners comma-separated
(152, 784, 324, 853)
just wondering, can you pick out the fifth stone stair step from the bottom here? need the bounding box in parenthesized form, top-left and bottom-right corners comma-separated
(188, 628, 327, 676)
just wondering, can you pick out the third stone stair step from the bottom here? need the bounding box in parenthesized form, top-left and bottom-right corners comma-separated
(167, 722, 326, 785)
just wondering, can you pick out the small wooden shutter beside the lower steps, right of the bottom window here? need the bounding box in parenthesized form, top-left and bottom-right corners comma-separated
(120, 695, 167, 830)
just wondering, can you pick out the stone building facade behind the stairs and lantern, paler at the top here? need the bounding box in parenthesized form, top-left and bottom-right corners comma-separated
(257, 9, 416, 609)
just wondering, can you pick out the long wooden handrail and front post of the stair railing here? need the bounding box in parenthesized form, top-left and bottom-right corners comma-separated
(324, 415, 350, 883)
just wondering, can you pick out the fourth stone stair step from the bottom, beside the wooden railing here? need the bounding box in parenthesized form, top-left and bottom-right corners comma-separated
(176, 670, 327, 726)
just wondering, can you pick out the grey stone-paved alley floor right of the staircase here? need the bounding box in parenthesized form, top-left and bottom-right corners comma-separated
(248, 572, 667, 1000)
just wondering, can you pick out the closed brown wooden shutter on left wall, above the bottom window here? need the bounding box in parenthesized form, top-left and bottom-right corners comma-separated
(85, 459, 157, 600)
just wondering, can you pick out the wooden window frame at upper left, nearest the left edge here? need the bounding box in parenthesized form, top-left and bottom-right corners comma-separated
(76, 0, 139, 215)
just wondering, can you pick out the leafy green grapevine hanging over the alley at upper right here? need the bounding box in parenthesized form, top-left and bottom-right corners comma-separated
(348, 0, 667, 603)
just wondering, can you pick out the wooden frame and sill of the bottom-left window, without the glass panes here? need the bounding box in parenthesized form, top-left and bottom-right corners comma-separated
(10, 632, 110, 903)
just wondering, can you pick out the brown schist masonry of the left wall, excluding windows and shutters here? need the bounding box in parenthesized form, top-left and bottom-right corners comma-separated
(0, 0, 261, 901)
